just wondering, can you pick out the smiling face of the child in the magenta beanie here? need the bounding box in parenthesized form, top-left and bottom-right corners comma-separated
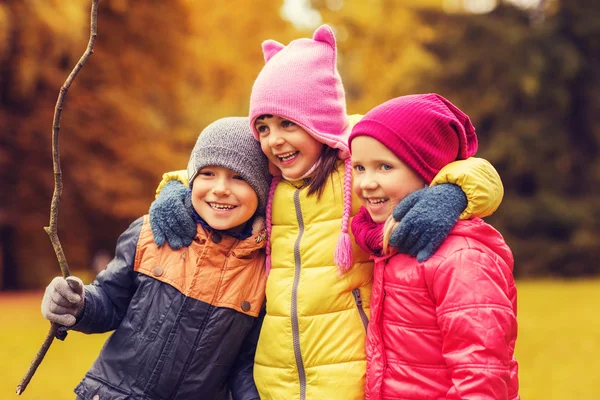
(352, 136, 426, 223)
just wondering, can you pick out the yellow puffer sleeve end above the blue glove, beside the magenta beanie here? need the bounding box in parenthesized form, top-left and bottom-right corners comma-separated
(431, 157, 504, 219)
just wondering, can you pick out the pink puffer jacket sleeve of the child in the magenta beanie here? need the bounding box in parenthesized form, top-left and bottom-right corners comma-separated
(426, 249, 517, 400)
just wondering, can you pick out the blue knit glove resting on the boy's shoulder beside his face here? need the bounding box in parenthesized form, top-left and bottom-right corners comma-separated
(150, 181, 196, 250)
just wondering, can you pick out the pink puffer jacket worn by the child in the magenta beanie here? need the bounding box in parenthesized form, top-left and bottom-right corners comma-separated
(367, 218, 519, 400)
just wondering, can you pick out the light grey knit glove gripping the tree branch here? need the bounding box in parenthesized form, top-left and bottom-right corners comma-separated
(42, 276, 85, 326)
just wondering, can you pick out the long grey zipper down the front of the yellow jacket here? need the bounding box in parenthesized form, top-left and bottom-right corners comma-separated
(291, 189, 306, 400)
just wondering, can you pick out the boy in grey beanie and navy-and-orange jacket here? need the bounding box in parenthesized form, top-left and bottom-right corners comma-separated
(42, 117, 270, 400)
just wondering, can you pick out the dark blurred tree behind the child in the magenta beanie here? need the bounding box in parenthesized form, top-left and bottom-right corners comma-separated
(414, 0, 600, 276)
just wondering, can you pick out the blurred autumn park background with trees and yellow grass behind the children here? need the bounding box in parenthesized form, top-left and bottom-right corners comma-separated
(0, 0, 600, 400)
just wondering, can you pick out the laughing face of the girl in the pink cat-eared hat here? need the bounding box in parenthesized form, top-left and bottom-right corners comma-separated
(254, 115, 324, 180)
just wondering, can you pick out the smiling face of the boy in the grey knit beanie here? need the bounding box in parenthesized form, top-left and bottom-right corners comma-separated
(192, 166, 258, 232)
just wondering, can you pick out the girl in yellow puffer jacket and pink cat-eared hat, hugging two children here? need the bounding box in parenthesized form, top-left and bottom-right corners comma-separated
(151, 26, 502, 400)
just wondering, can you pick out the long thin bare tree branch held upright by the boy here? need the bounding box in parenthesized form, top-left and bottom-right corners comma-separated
(17, 0, 99, 395)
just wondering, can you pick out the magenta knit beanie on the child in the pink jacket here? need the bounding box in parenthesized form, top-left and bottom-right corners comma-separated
(348, 93, 477, 183)
